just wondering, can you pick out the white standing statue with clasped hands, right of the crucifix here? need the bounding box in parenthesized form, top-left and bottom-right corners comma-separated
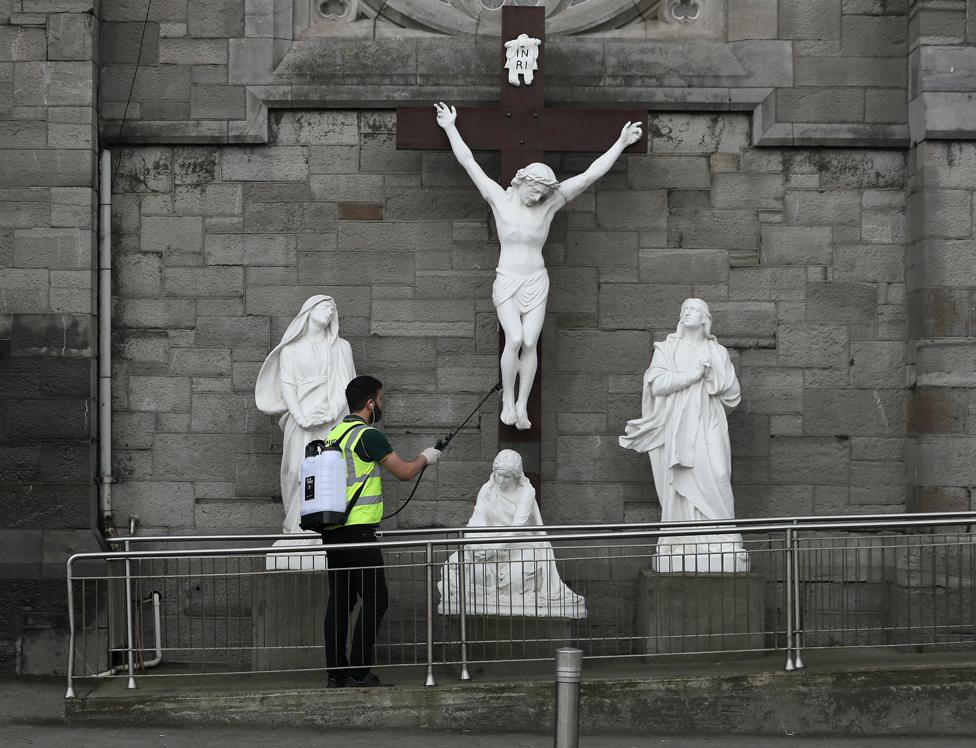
(620, 299, 749, 572)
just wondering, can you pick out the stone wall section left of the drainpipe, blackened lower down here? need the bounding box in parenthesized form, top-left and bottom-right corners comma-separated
(0, 0, 97, 672)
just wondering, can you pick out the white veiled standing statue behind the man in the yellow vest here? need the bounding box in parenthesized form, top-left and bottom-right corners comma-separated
(254, 295, 356, 533)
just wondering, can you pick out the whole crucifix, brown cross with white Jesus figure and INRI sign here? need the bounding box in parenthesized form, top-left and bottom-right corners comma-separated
(397, 5, 647, 497)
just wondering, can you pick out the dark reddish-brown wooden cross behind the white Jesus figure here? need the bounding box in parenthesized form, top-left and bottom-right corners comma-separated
(397, 5, 647, 498)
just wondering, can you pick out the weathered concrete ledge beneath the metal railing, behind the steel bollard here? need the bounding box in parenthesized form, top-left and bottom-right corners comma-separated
(65, 650, 976, 736)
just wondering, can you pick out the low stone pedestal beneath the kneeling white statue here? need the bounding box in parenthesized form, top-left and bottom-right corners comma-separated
(445, 616, 573, 672)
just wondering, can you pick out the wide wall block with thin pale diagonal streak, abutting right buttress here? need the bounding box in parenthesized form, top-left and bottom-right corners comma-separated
(803, 389, 906, 436)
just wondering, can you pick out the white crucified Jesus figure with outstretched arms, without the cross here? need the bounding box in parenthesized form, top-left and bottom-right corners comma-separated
(435, 103, 641, 430)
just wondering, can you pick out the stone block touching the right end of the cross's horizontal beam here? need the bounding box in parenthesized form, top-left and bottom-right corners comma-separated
(648, 113, 749, 154)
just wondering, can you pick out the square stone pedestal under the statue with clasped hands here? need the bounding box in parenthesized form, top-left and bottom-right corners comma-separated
(637, 569, 765, 654)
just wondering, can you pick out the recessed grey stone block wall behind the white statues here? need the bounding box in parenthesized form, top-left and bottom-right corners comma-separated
(114, 111, 906, 531)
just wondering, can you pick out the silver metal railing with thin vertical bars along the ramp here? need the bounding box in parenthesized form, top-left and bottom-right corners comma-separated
(67, 512, 976, 697)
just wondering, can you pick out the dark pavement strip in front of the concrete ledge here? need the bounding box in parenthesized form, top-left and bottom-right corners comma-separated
(0, 676, 976, 748)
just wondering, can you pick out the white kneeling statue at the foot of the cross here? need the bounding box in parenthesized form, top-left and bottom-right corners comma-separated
(437, 449, 586, 618)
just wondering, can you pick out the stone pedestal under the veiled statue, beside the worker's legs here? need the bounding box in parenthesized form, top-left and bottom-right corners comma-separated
(251, 559, 329, 670)
